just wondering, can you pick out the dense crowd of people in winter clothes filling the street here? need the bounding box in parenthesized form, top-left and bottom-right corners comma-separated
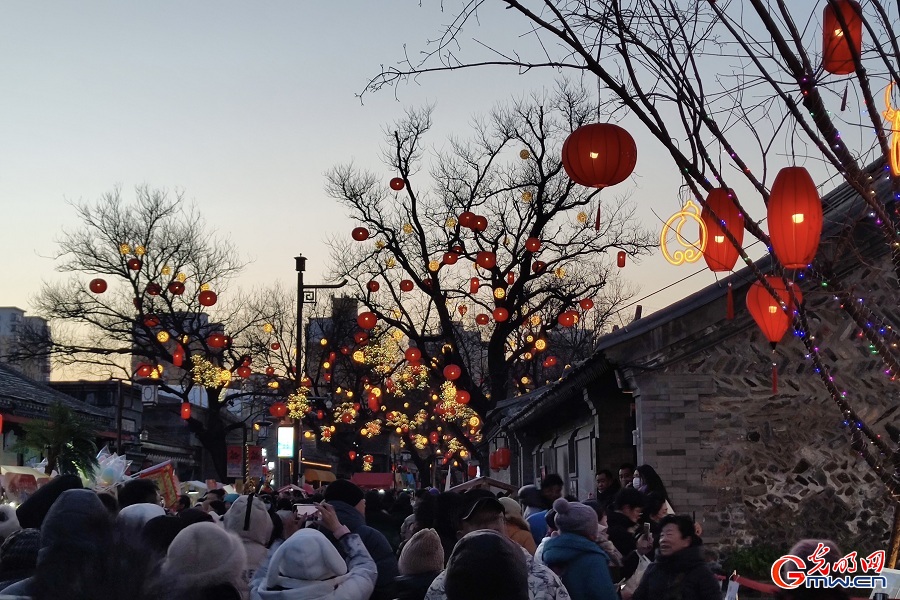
(0, 465, 856, 600)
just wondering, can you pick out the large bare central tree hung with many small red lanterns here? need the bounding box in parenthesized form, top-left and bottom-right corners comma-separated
(327, 85, 654, 468)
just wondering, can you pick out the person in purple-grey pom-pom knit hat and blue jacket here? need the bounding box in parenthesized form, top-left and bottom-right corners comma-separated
(541, 498, 618, 600)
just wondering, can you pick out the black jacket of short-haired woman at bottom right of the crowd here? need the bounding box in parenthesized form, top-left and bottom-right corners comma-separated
(632, 546, 722, 600)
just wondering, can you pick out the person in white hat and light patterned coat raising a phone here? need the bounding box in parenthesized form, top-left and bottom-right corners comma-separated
(251, 504, 378, 600)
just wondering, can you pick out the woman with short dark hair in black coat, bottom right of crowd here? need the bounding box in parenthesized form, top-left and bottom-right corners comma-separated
(632, 515, 722, 600)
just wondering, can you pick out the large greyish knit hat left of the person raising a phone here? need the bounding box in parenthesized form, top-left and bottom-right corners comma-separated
(162, 523, 247, 590)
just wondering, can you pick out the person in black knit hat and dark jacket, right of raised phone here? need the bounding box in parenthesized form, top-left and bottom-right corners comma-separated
(325, 479, 399, 600)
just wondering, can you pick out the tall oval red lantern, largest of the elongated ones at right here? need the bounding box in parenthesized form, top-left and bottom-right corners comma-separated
(767, 167, 822, 269)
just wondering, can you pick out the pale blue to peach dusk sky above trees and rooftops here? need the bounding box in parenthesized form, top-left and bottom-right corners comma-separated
(0, 0, 776, 324)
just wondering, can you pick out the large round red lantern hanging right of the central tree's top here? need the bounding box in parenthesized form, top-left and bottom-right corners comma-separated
(562, 123, 637, 188)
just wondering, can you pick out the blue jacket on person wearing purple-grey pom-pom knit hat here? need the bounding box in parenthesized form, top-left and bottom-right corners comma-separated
(541, 533, 618, 600)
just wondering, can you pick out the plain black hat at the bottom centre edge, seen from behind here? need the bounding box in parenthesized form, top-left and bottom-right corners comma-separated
(444, 529, 529, 600)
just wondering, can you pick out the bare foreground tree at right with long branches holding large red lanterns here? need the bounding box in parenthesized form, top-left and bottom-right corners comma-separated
(367, 0, 900, 552)
